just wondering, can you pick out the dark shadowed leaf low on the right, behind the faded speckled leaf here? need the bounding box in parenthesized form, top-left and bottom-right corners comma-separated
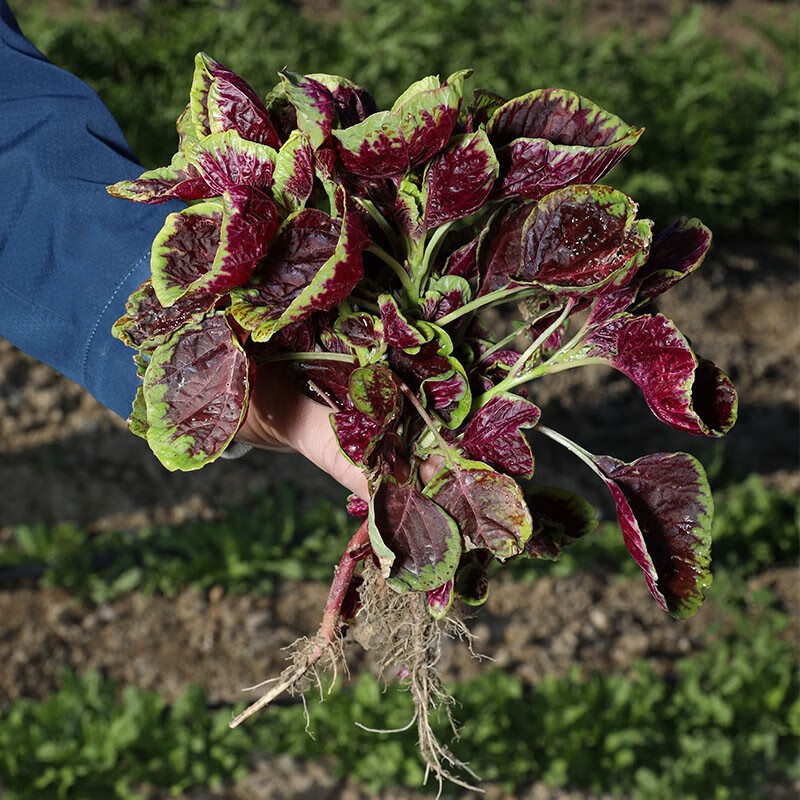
(524, 486, 597, 560)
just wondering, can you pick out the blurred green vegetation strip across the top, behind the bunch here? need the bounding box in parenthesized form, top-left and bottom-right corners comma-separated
(11, 0, 800, 239)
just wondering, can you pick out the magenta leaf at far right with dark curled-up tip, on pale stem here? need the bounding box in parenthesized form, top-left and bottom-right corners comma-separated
(583, 314, 738, 436)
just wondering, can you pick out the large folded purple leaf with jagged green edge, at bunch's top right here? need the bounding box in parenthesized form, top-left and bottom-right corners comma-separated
(486, 89, 642, 200)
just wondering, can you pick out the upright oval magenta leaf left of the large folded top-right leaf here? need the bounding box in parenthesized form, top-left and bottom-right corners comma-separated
(425, 131, 498, 229)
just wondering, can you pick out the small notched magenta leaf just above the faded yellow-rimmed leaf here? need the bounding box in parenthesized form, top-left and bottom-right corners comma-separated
(461, 394, 542, 478)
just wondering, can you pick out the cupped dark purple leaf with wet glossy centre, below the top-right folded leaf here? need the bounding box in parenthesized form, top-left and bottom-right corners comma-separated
(518, 186, 637, 294)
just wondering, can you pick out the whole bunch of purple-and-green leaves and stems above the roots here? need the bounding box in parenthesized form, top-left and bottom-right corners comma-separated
(110, 54, 737, 740)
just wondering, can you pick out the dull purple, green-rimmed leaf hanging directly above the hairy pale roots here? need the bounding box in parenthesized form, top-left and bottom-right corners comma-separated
(369, 476, 461, 591)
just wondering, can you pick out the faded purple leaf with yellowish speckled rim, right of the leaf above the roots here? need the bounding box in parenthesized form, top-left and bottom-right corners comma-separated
(424, 459, 532, 559)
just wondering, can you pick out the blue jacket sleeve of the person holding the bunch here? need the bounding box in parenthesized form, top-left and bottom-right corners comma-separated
(0, 0, 182, 417)
